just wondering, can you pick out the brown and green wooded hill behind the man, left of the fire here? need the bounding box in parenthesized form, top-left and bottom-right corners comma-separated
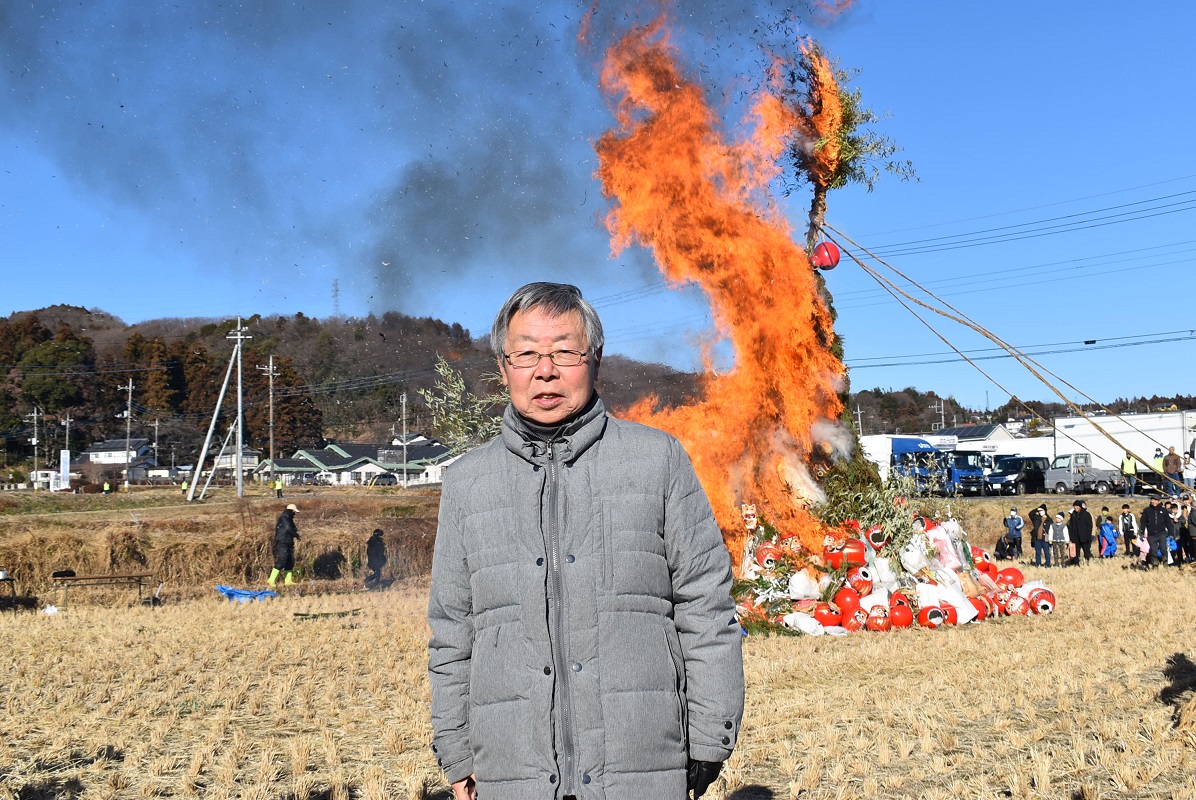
(0, 305, 697, 463)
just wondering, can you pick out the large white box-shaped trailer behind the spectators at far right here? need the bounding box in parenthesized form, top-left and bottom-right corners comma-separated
(1047, 410, 1196, 491)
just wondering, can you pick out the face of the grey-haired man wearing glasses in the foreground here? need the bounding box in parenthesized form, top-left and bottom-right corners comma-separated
(499, 303, 598, 425)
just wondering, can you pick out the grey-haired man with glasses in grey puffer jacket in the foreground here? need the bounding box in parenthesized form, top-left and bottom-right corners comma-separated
(428, 283, 744, 800)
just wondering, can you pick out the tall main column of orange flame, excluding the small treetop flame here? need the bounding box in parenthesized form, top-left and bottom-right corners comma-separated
(597, 22, 844, 558)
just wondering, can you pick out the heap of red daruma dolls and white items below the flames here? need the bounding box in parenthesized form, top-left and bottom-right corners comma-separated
(733, 505, 1055, 635)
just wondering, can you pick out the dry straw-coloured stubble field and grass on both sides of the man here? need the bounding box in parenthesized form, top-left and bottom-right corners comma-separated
(0, 494, 1196, 800)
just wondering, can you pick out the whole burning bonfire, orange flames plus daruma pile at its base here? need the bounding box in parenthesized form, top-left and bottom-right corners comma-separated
(596, 15, 1055, 633)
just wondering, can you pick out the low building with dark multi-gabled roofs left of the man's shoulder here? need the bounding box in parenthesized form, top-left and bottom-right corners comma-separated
(254, 434, 454, 486)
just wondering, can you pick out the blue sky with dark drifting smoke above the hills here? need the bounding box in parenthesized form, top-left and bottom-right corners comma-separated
(0, 0, 1196, 408)
